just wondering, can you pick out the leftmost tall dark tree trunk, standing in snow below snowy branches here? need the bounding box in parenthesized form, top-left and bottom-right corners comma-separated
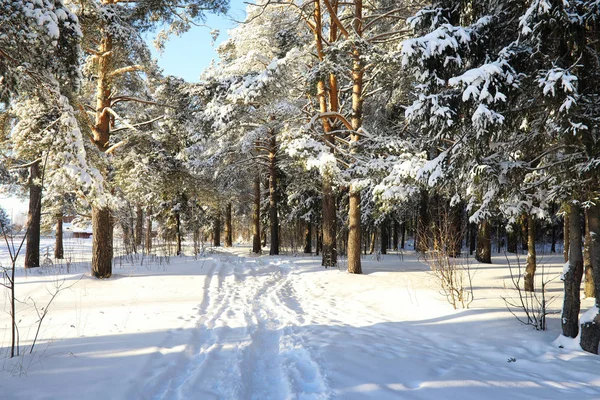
(25, 162, 42, 268)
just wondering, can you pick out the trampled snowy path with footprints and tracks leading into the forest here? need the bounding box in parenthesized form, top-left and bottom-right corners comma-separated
(130, 256, 328, 399)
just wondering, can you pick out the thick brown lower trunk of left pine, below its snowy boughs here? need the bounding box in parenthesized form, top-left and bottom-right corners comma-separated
(92, 206, 113, 279)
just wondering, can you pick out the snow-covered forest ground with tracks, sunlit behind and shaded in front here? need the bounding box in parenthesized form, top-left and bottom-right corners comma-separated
(0, 240, 600, 400)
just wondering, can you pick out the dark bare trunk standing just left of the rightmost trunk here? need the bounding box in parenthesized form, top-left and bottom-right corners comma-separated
(561, 204, 583, 338)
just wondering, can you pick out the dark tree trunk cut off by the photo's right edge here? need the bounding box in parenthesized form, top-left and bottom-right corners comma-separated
(580, 205, 600, 354)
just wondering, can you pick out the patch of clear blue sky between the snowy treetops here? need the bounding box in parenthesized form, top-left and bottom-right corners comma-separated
(152, 0, 246, 82)
